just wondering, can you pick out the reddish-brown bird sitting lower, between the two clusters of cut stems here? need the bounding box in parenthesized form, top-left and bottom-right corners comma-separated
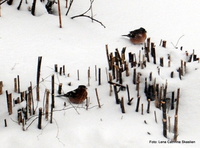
(57, 85, 88, 104)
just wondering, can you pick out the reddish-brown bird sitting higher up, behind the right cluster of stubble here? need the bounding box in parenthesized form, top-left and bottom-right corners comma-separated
(122, 27, 147, 44)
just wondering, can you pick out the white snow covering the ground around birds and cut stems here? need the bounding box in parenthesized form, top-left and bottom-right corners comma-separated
(0, 0, 200, 148)
